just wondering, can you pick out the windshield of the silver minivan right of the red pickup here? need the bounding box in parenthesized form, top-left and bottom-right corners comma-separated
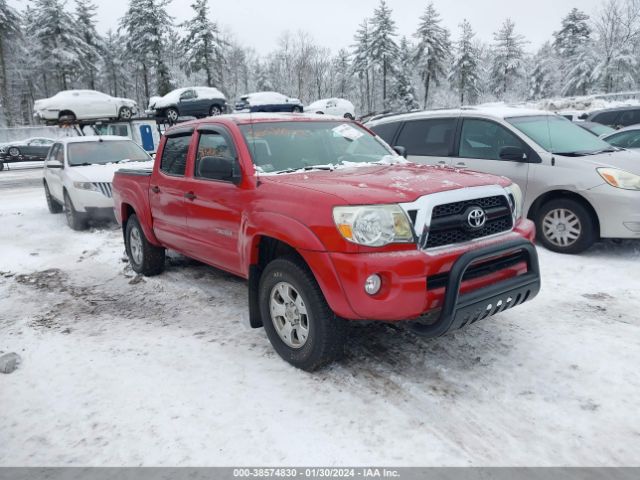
(506, 115, 615, 156)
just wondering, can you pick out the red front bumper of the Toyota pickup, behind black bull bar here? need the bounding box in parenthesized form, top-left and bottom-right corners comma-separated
(304, 220, 539, 330)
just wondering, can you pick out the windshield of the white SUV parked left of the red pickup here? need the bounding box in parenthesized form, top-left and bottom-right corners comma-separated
(68, 140, 151, 166)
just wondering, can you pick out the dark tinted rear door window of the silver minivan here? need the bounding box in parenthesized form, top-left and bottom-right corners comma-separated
(396, 118, 456, 157)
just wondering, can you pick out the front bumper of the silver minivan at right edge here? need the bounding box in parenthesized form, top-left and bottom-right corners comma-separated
(585, 184, 640, 238)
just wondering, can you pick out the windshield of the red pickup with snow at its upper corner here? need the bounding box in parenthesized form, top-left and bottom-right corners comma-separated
(240, 121, 395, 173)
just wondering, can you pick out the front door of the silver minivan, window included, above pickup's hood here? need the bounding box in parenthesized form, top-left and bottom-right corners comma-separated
(453, 118, 534, 192)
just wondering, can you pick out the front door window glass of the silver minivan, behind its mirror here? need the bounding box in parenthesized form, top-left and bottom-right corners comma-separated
(458, 118, 526, 160)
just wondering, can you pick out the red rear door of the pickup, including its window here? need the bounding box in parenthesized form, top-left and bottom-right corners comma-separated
(149, 129, 193, 251)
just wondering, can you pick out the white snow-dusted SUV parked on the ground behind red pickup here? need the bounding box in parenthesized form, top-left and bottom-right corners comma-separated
(43, 136, 153, 230)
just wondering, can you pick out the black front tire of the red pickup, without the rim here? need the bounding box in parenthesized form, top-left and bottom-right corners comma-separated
(258, 257, 347, 372)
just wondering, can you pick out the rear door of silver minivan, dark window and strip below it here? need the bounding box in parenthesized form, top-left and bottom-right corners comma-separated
(395, 117, 458, 165)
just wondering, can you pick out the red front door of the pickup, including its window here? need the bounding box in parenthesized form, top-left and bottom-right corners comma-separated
(185, 125, 248, 274)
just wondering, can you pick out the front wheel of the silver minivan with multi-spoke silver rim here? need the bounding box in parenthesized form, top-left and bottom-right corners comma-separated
(535, 198, 598, 254)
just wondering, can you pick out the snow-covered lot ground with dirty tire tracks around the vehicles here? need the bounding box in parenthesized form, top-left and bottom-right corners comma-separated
(0, 171, 640, 466)
